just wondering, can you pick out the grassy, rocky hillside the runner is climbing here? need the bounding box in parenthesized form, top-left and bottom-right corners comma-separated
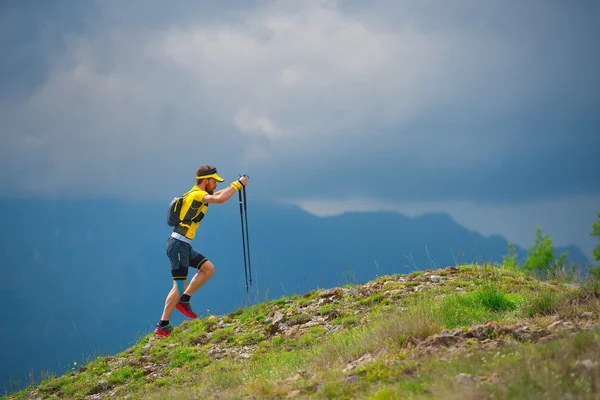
(5, 265, 600, 400)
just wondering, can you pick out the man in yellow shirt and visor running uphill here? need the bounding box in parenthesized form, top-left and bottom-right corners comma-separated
(154, 165, 248, 336)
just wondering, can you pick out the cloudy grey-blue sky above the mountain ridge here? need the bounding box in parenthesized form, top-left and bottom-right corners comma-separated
(0, 0, 600, 255)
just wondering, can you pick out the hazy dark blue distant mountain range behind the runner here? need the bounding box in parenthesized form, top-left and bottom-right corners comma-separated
(0, 199, 588, 388)
